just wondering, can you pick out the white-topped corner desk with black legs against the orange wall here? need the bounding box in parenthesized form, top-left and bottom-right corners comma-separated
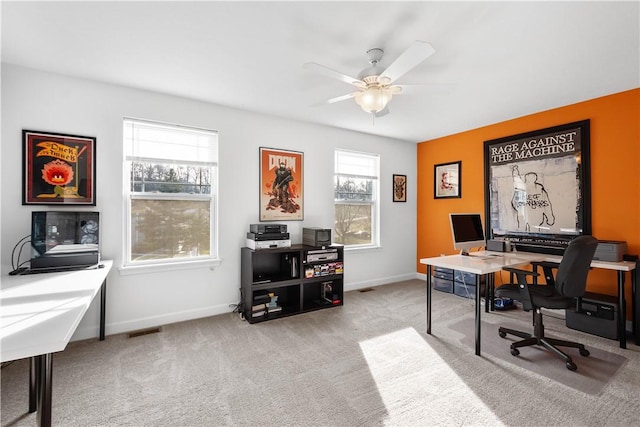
(420, 251, 640, 356)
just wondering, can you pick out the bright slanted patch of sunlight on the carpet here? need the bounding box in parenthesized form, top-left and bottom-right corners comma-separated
(360, 328, 503, 426)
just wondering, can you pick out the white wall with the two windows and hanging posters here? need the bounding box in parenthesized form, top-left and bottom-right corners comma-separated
(0, 64, 417, 339)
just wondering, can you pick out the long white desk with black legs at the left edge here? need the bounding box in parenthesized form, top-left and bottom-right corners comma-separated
(0, 261, 113, 426)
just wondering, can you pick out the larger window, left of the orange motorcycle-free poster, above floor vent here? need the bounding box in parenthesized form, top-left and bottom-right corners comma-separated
(124, 119, 218, 266)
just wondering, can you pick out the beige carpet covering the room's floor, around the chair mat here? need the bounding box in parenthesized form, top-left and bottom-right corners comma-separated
(0, 280, 640, 427)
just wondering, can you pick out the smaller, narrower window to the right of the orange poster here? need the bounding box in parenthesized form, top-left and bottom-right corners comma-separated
(333, 150, 380, 247)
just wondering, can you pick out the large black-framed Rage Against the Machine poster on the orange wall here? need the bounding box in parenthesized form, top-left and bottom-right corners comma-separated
(484, 120, 591, 239)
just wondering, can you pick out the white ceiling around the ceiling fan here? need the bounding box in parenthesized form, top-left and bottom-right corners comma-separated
(1, 1, 640, 142)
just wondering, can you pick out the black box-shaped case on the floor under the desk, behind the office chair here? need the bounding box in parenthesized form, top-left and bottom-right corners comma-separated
(565, 292, 620, 340)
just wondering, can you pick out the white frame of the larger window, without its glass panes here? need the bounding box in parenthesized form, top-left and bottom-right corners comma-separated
(120, 117, 220, 274)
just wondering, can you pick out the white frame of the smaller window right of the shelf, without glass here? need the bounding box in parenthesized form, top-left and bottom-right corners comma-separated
(333, 148, 380, 250)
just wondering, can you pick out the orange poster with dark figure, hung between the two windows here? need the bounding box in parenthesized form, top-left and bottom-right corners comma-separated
(260, 147, 304, 221)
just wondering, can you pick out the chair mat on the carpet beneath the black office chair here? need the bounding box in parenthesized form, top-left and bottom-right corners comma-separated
(449, 318, 627, 395)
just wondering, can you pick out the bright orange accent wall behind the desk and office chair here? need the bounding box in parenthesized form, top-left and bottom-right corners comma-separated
(416, 89, 640, 303)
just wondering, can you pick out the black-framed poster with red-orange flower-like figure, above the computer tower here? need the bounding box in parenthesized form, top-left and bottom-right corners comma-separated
(22, 130, 96, 206)
